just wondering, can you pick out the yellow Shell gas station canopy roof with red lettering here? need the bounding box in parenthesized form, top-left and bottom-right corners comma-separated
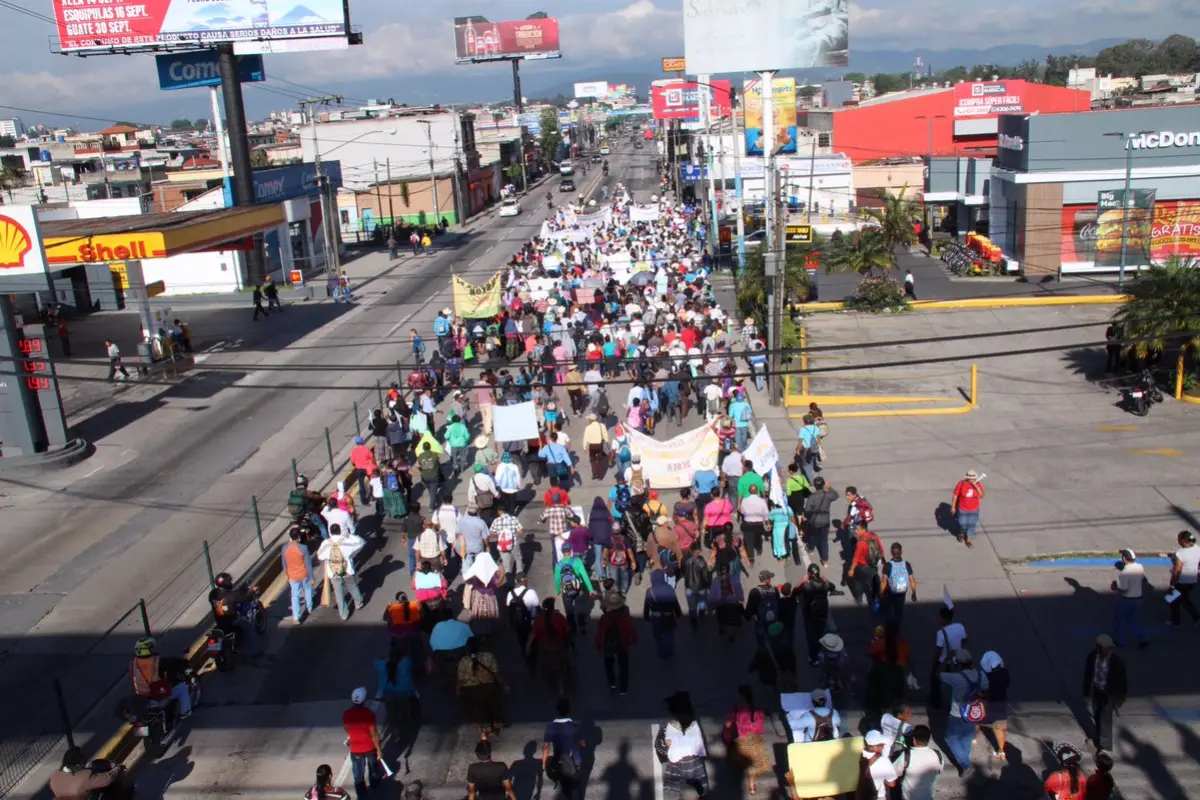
(40, 204, 286, 267)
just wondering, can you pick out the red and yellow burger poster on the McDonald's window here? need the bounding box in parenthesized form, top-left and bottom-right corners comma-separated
(1062, 198, 1200, 269)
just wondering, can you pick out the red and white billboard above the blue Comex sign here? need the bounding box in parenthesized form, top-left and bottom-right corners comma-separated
(52, 0, 349, 53)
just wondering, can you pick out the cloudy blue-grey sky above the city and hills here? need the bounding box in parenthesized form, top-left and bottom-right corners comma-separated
(0, 0, 1200, 128)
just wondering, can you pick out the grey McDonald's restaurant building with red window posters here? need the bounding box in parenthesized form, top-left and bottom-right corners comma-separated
(989, 106, 1200, 278)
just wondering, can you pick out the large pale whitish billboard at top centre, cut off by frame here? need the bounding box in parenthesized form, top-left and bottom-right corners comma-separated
(683, 0, 850, 74)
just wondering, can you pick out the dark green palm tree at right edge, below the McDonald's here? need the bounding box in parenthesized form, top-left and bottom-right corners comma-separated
(1112, 255, 1200, 357)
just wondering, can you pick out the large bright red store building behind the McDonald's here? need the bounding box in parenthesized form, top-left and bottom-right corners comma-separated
(808, 80, 1091, 163)
